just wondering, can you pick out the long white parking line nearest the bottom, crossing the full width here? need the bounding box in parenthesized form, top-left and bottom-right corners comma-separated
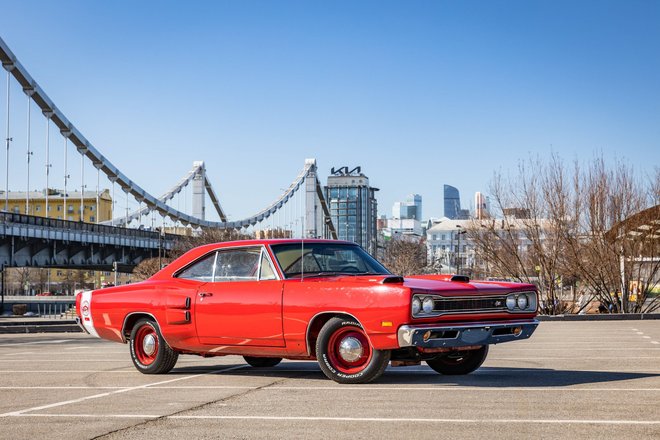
(11, 414, 660, 425)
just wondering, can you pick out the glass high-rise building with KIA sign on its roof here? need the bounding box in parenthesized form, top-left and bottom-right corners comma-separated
(325, 167, 378, 255)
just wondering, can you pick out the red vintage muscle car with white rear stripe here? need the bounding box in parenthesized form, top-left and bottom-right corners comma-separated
(76, 239, 538, 383)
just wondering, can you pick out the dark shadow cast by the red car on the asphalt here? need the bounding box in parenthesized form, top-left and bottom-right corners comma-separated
(170, 362, 660, 388)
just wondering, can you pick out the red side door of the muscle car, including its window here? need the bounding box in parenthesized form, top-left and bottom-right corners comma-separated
(195, 246, 284, 347)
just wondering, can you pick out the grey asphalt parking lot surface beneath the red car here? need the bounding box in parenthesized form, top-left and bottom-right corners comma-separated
(0, 321, 660, 440)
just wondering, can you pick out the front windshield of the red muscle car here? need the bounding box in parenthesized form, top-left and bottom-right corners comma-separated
(271, 242, 390, 278)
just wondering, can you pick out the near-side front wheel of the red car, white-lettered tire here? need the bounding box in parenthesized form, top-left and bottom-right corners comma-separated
(316, 317, 390, 384)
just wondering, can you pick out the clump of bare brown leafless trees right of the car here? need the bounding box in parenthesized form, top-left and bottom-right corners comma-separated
(468, 155, 660, 313)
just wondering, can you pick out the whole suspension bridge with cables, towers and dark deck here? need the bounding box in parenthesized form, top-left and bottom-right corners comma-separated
(0, 38, 337, 270)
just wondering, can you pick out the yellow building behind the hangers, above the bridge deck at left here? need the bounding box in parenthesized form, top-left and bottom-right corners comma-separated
(0, 188, 112, 223)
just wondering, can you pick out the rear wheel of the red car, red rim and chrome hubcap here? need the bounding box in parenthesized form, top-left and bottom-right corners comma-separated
(129, 318, 179, 374)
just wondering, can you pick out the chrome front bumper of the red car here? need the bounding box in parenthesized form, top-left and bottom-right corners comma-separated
(398, 319, 539, 348)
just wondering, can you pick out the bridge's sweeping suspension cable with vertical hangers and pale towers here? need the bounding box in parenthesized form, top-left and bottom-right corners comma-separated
(0, 38, 337, 238)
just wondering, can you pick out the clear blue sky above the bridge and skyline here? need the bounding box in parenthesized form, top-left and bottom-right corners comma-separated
(0, 0, 660, 219)
